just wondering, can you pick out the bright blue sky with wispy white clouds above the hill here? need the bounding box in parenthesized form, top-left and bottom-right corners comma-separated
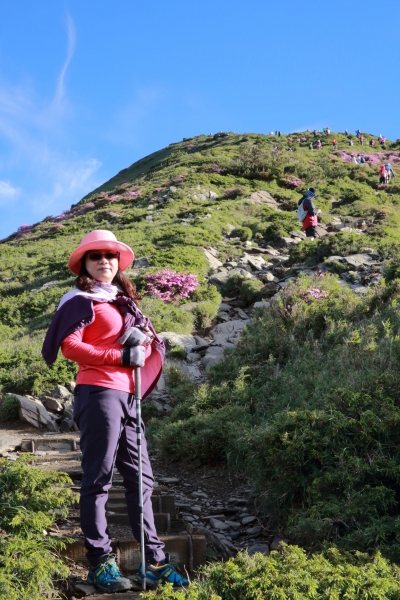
(0, 0, 400, 238)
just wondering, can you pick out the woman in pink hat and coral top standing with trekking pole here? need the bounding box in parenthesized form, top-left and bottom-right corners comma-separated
(42, 230, 188, 593)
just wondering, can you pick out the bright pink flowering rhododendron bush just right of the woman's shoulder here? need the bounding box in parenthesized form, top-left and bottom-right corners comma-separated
(144, 269, 199, 303)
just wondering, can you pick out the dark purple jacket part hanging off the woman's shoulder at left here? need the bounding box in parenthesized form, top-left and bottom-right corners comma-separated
(42, 296, 94, 366)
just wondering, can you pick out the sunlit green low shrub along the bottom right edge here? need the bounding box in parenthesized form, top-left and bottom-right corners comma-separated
(148, 544, 400, 600)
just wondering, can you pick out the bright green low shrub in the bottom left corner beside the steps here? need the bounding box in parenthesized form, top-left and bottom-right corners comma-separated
(0, 456, 72, 600)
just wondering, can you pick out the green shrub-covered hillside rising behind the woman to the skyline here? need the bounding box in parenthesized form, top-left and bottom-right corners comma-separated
(0, 133, 400, 572)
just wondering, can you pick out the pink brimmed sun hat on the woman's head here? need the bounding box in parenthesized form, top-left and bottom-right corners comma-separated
(68, 229, 135, 275)
